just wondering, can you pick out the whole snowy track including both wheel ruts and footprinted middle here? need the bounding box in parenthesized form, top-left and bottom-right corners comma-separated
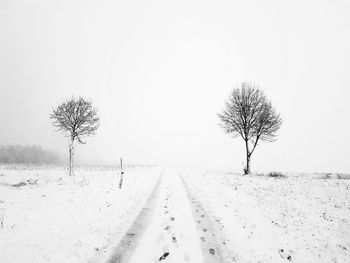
(107, 170, 224, 263)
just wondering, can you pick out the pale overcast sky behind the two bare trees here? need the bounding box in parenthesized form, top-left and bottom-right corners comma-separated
(0, 0, 350, 172)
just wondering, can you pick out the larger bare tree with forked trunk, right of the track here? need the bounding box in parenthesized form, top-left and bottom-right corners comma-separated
(218, 82, 282, 174)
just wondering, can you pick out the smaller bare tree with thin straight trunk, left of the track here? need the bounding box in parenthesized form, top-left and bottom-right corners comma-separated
(50, 97, 100, 175)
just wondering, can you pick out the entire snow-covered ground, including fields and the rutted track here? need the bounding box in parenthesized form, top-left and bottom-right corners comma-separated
(0, 167, 350, 263)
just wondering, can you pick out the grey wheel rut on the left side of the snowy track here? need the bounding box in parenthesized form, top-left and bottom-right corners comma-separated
(106, 171, 164, 263)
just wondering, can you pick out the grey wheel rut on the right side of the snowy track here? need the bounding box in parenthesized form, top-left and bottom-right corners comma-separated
(180, 175, 235, 263)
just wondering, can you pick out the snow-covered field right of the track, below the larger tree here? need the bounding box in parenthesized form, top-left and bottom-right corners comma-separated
(183, 171, 350, 262)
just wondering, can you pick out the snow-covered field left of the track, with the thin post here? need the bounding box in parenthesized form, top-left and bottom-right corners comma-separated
(0, 167, 160, 262)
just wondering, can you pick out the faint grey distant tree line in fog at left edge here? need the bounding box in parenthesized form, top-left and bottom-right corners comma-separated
(0, 145, 62, 164)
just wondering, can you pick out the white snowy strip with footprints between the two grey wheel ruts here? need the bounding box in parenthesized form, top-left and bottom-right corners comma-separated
(124, 169, 204, 263)
